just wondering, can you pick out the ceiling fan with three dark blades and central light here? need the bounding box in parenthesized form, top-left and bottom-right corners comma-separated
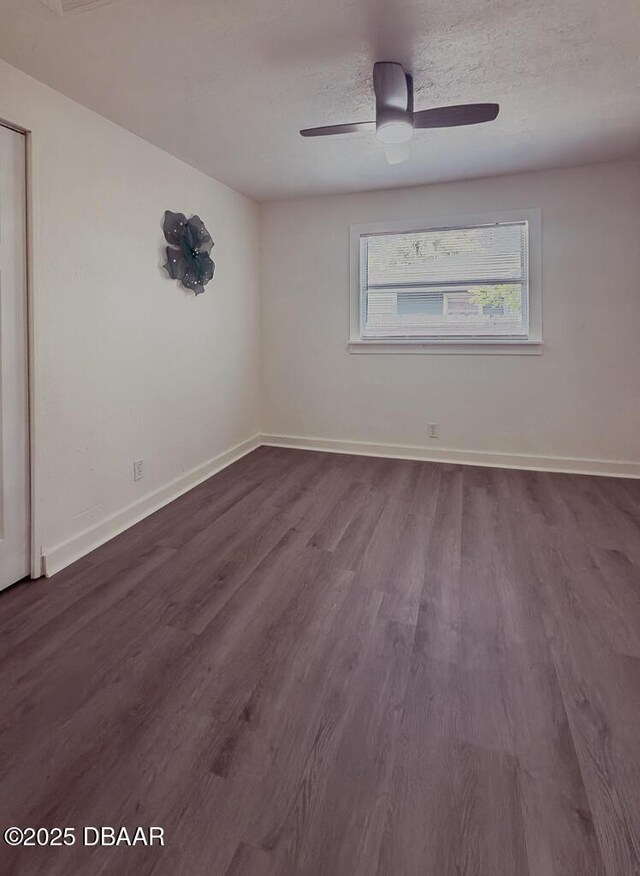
(300, 61, 500, 163)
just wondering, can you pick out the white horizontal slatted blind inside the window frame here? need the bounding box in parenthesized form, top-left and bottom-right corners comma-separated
(360, 221, 529, 340)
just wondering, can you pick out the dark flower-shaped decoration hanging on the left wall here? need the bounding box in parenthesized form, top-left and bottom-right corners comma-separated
(162, 210, 216, 295)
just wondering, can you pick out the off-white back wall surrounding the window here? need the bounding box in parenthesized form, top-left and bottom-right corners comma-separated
(261, 162, 640, 473)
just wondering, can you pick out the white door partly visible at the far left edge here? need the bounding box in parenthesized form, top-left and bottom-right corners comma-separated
(0, 126, 29, 590)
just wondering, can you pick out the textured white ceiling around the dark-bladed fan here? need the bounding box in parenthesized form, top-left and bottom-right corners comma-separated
(0, 0, 640, 200)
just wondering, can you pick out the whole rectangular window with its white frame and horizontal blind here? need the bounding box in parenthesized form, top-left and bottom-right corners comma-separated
(351, 211, 541, 351)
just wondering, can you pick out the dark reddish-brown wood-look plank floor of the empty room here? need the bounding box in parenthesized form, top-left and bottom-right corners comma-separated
(0, 448, 640, 876)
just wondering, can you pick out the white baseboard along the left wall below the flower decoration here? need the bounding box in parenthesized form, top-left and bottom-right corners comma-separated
(42, 435, 262, 578)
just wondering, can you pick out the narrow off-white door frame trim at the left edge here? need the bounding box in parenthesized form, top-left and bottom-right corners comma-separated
(0, 118, 43, 578)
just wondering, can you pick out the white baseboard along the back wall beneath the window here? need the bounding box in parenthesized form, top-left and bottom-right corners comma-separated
(260, 435, 640, 478)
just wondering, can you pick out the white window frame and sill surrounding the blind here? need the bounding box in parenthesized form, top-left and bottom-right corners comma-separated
(347, 209, 543, 355)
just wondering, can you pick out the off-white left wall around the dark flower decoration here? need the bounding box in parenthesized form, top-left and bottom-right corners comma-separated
(0, 62, 259, 565)
